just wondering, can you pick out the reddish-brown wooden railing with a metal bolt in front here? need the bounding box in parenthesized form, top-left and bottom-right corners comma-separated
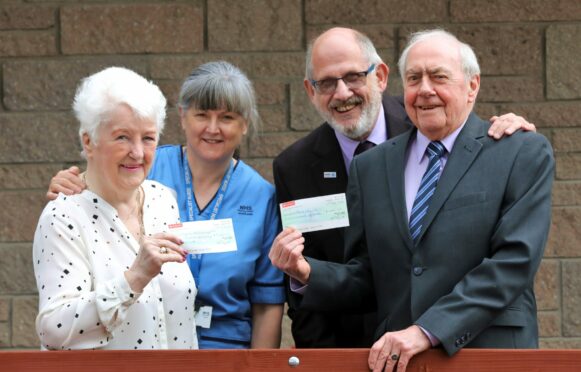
(0, 349, 581, 372)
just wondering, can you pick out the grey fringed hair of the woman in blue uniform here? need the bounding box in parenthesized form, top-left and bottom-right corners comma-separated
(178, 61, 260, 134)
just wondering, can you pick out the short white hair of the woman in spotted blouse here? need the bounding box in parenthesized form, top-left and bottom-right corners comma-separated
(73, 67, 166, 150)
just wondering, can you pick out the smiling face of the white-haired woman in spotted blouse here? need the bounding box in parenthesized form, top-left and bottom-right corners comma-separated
(83, 104, 158, 193)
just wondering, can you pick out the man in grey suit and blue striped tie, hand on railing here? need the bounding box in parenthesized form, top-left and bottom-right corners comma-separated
(270, 30, 554, 372)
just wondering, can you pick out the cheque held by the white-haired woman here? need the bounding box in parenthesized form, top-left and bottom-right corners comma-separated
(168, 218, 238, 254)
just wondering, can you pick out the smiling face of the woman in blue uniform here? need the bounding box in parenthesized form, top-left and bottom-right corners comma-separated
(180, 108, 248, 163)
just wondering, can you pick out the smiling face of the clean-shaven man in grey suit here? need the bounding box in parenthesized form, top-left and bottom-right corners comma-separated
(403, 37, 480, 141)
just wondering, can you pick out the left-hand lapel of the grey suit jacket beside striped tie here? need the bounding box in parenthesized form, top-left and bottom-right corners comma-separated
(385, 131, 415, 250)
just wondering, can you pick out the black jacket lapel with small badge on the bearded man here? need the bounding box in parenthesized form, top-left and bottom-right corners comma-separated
(311, 124, 347, 195)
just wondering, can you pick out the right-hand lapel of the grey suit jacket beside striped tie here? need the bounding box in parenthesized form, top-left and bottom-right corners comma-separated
(418, 113, 488, 246)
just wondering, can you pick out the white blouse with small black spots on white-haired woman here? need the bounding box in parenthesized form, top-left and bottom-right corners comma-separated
(33, 181, 198, 350)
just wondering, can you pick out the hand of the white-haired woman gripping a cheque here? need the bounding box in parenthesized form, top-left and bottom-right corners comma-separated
(125, 233, 188, 293)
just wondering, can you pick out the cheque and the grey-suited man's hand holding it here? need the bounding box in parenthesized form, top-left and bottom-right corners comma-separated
(268, 194, 349, 284)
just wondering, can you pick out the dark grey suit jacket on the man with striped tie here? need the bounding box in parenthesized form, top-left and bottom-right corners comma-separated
(301, 114, 554, 354)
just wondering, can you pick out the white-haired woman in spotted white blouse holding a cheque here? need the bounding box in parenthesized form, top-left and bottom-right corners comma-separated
(33, 67, 197, 350)
